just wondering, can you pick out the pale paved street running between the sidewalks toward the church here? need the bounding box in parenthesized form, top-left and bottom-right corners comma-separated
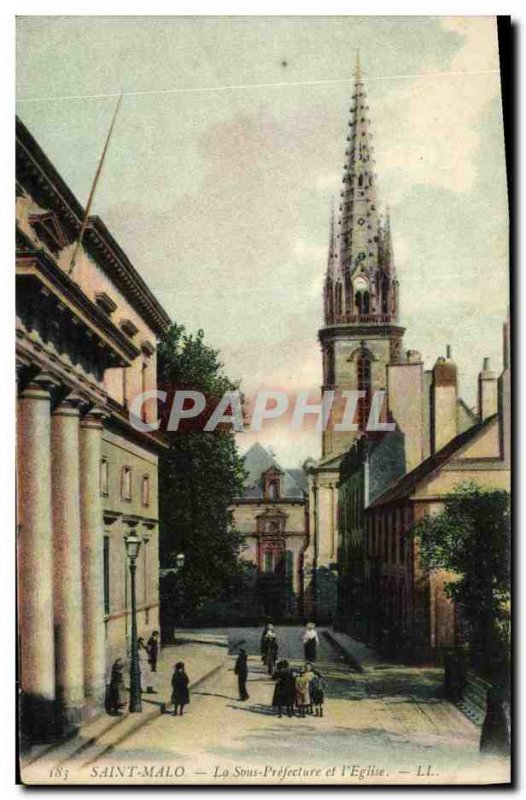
(29, 627, 503, 784)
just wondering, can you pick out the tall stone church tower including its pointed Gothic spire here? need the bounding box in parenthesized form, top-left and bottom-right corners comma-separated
(319, 57, 404, 459)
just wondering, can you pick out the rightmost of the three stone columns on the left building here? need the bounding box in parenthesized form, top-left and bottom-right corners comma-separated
(79, 410, 106, 715)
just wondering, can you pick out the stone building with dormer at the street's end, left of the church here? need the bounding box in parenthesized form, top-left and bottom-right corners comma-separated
(233, 442, 309, 620)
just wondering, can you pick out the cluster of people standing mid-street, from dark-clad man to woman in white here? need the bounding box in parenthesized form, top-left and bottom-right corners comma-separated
(234, 622, 327, 717)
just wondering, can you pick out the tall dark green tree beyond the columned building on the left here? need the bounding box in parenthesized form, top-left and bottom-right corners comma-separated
(157, 325, 248, 620)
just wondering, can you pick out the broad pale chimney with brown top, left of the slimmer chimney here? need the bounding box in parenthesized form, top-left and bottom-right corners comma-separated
(430, 345, 458, 453)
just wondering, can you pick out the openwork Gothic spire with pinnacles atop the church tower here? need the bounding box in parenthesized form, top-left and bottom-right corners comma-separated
(324, 55, 397, 325)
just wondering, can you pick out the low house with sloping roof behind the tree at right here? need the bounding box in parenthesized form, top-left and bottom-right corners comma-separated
(364, 325, 511, 660)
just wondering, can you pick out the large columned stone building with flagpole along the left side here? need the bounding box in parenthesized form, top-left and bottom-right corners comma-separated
(16, 120, 170, 740)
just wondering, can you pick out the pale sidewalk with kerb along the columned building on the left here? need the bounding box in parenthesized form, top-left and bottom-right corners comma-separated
(20, 631, 229, 783)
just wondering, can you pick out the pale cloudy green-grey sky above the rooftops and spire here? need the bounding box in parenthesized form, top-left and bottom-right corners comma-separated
(16, 16, 508, 467)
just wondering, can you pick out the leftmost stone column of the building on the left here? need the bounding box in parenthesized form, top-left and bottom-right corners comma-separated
(17, 378, 55, 740)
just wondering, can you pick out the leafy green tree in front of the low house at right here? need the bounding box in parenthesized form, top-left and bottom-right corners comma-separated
(413, 482, 510, 670)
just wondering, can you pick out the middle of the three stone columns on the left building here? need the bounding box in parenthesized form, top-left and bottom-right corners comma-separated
(51, 395, 84, 735)
